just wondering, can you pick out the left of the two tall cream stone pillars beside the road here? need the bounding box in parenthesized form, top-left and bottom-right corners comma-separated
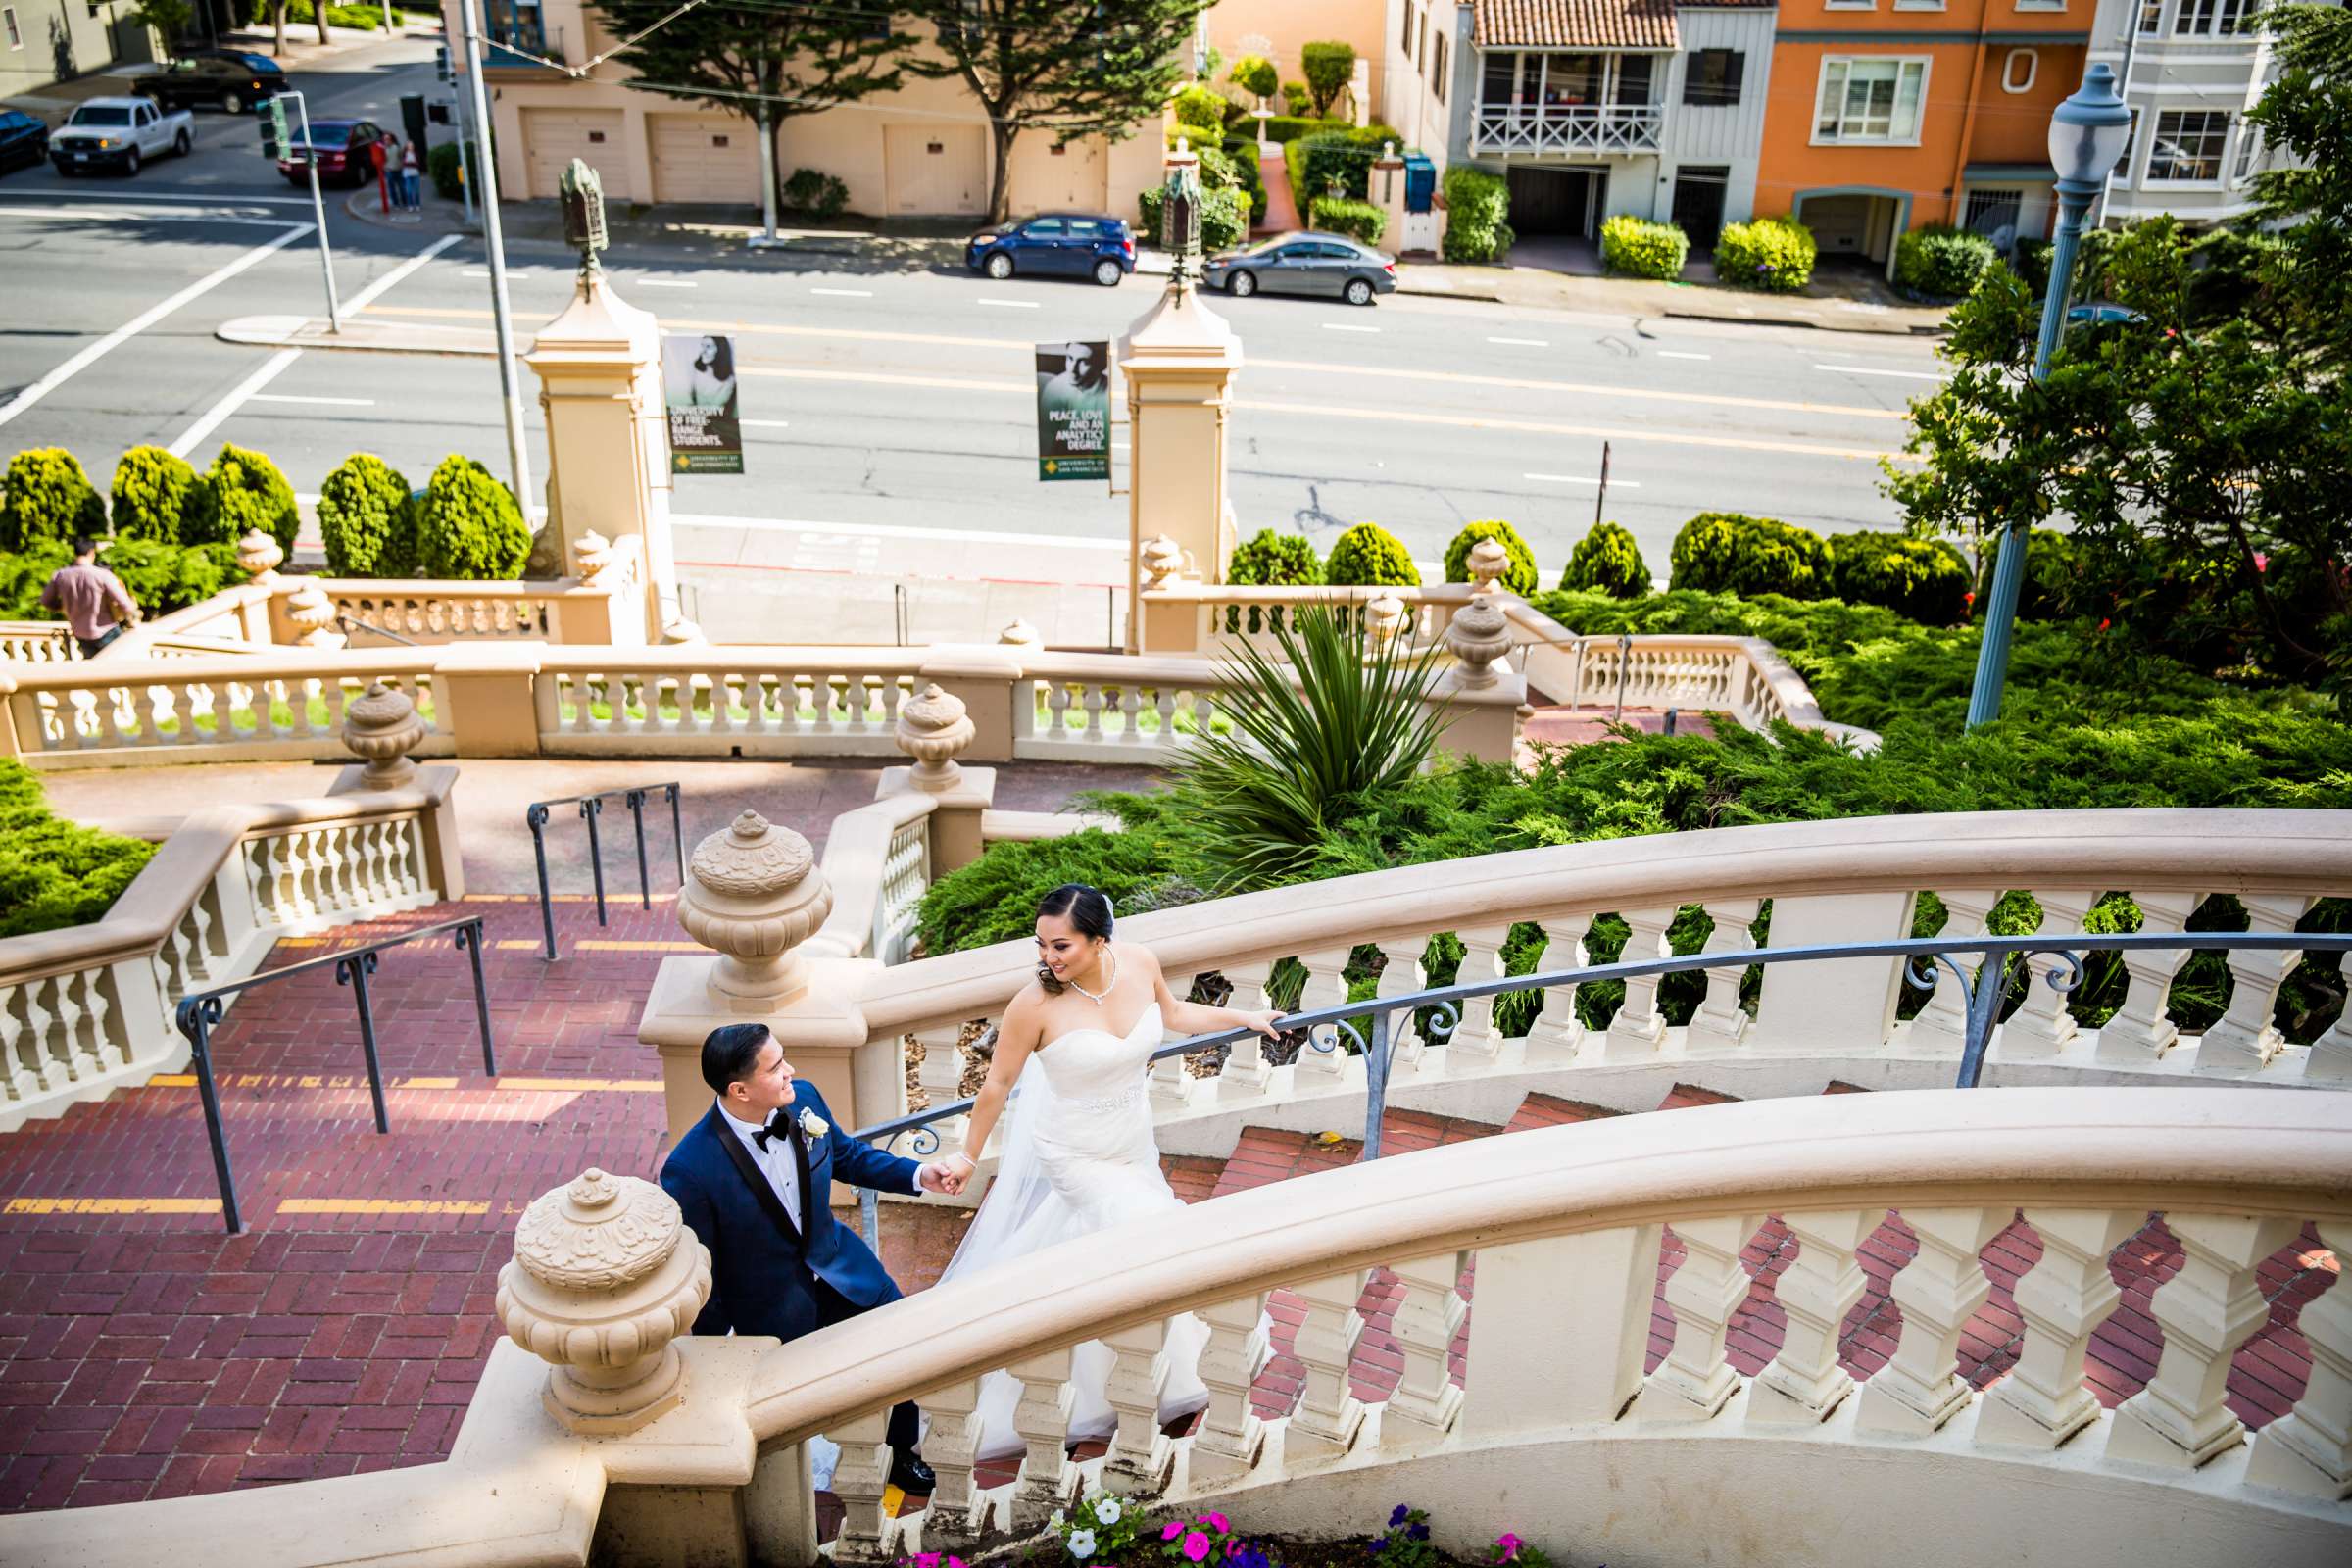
(517, 272, 677, 642)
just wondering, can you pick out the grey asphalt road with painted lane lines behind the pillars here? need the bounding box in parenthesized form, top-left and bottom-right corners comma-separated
(0, 40, 1938, 606)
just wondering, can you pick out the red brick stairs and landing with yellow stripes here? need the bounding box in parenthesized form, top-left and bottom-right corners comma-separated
(0, 901, 2335, 1514)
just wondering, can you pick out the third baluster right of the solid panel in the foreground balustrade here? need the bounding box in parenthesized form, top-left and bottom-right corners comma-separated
(1858, 1208, 2011, 1437)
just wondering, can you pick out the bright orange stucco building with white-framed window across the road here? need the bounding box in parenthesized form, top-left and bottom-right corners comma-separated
(1754, 0, 2093, 266)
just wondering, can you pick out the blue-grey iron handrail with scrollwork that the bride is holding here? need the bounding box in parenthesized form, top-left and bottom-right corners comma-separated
(852, 931, 2352, 1246)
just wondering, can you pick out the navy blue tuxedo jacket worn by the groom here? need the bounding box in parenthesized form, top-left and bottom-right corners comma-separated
(661, 1079, 922, 1340)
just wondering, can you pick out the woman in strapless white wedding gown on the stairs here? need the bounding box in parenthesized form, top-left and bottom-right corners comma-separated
(941, 882, 1280, 1460)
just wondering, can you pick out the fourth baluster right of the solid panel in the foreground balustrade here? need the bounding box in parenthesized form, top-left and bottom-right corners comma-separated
(1976, 1208, 2145, 1448)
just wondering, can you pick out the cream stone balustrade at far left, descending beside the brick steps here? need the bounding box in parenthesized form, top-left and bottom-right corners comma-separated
(0, 768, 466, 1133)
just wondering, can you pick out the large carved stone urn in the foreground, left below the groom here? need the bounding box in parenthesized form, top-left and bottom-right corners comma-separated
(499, 1168, 710, 1437)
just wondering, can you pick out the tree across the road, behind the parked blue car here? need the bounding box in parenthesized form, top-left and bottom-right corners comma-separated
(904, 0, 1206, 223)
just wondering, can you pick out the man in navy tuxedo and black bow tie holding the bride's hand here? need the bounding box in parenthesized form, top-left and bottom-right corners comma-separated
(661, 1022, 953, 1495)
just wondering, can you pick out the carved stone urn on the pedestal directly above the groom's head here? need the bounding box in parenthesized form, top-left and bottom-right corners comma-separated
(677, 811, 833, 1013)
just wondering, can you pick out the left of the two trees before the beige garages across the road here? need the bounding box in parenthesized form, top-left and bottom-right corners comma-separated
(590, 0, 915, 237)
